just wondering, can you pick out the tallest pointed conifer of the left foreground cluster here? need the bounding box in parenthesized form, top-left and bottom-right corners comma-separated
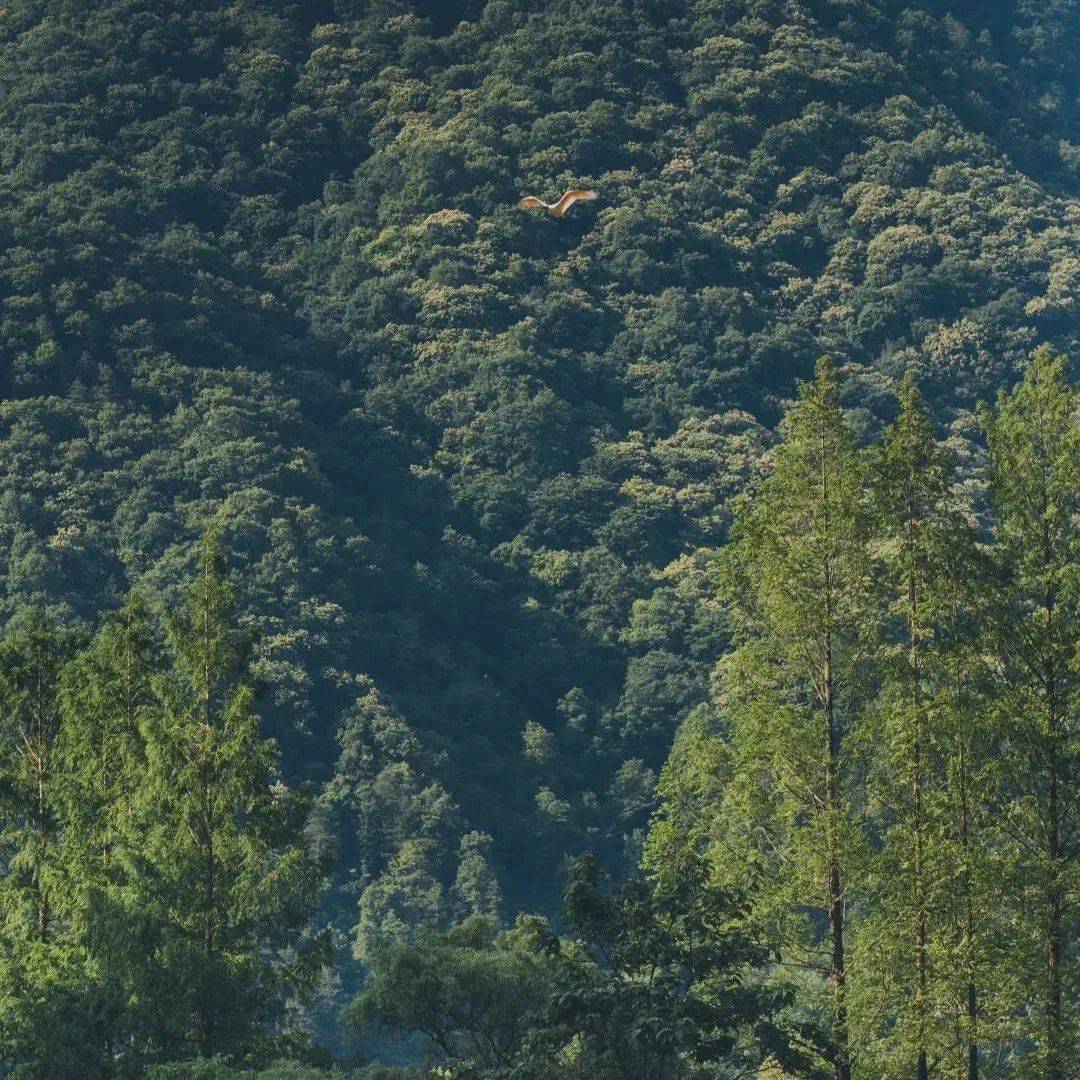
(130, 530, 321, 1057)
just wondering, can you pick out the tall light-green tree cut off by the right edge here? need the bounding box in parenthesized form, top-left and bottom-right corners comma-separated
(986, 350, 1080, 1080)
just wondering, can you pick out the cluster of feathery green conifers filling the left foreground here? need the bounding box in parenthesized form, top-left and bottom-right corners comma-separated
(0, 531, 326, 1078)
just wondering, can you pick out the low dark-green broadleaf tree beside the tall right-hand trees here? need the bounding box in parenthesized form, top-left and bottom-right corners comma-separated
(546, 845, 820, 1080)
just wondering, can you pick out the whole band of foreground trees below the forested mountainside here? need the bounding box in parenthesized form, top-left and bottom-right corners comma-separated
(0, 350, 1080, 1080)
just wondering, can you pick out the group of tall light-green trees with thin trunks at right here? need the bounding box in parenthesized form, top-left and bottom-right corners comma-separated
(669, 351, 1080, 1080)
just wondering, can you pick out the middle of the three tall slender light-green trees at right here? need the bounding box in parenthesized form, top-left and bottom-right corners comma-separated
(859, 375, 993, 1080)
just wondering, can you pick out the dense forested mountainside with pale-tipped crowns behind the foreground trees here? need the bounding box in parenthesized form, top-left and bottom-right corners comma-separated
(0, 0, 1080, 1076)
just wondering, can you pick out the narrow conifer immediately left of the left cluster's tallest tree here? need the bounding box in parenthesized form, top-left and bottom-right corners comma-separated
(46, 593, 161, 1077)
